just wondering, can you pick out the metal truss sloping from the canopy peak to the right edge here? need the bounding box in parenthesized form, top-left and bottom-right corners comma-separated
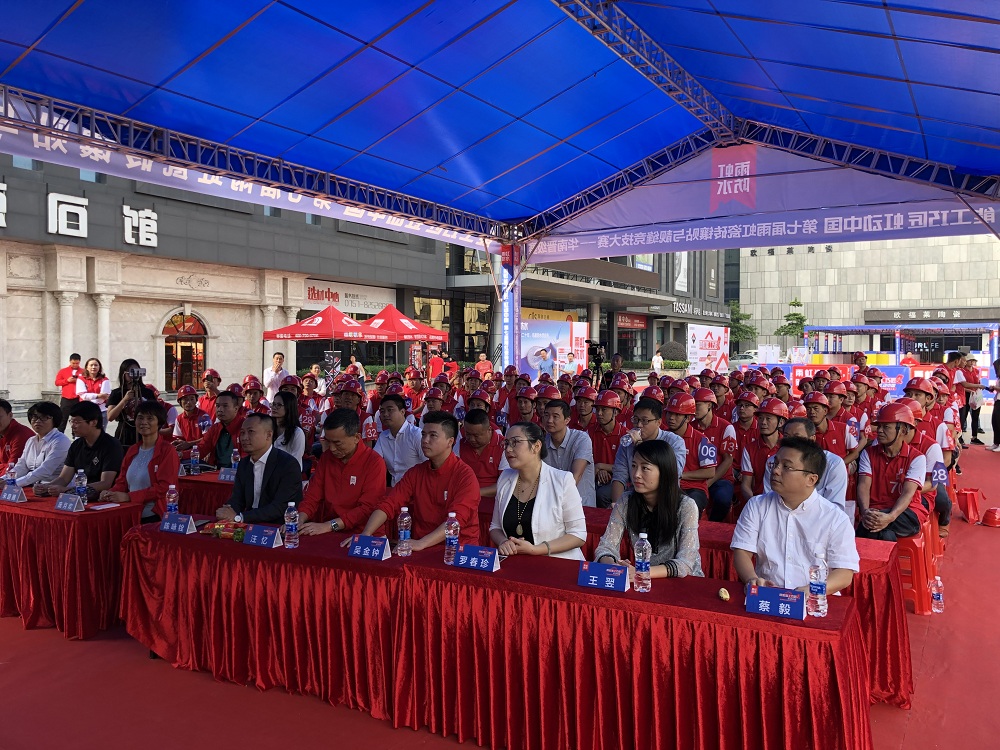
(739, 120, 1000, 200)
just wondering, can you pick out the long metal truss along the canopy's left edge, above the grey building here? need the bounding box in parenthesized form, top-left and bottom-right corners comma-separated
(0, 85, 510, 240)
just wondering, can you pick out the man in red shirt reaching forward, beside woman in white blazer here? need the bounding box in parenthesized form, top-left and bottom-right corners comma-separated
(354, 411, 479, 552)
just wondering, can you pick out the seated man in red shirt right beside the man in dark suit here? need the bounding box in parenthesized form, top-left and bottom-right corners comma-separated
(299, 409, 385, 536)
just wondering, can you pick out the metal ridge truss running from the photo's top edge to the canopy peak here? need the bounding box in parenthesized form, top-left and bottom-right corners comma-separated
(553, 0, 739, 143)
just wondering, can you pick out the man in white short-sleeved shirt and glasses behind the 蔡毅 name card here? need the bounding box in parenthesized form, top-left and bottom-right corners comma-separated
(730, 438, 860, 594)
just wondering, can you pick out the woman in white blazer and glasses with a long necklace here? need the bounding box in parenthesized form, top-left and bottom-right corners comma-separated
(490, 422, 587, 560)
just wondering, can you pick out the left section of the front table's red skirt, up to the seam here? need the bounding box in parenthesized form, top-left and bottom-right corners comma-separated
(122, 526, 402, 719)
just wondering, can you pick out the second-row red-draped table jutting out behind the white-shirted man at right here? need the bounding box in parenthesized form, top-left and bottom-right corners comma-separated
(479, 506, 913, 708)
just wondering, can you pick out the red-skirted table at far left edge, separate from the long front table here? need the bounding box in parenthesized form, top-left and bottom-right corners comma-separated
(0, 489, 142, 638)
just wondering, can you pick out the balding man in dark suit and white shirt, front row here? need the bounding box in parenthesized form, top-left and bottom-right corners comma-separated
(215, 413, 302, 523)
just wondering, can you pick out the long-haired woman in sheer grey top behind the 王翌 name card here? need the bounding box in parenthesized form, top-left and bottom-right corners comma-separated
(594, 440, 704, 578)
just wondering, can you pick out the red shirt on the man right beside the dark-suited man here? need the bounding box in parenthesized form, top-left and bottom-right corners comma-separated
(299, 442, 385, 533)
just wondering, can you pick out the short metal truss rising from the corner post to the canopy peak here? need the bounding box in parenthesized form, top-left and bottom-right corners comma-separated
(514, 129, 719, 242)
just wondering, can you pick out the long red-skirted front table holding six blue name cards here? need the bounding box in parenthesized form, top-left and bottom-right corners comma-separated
(122, 527, 871, 750)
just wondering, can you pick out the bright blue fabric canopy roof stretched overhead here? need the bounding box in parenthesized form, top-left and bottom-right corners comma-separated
(0, 0, 1000, 222)
